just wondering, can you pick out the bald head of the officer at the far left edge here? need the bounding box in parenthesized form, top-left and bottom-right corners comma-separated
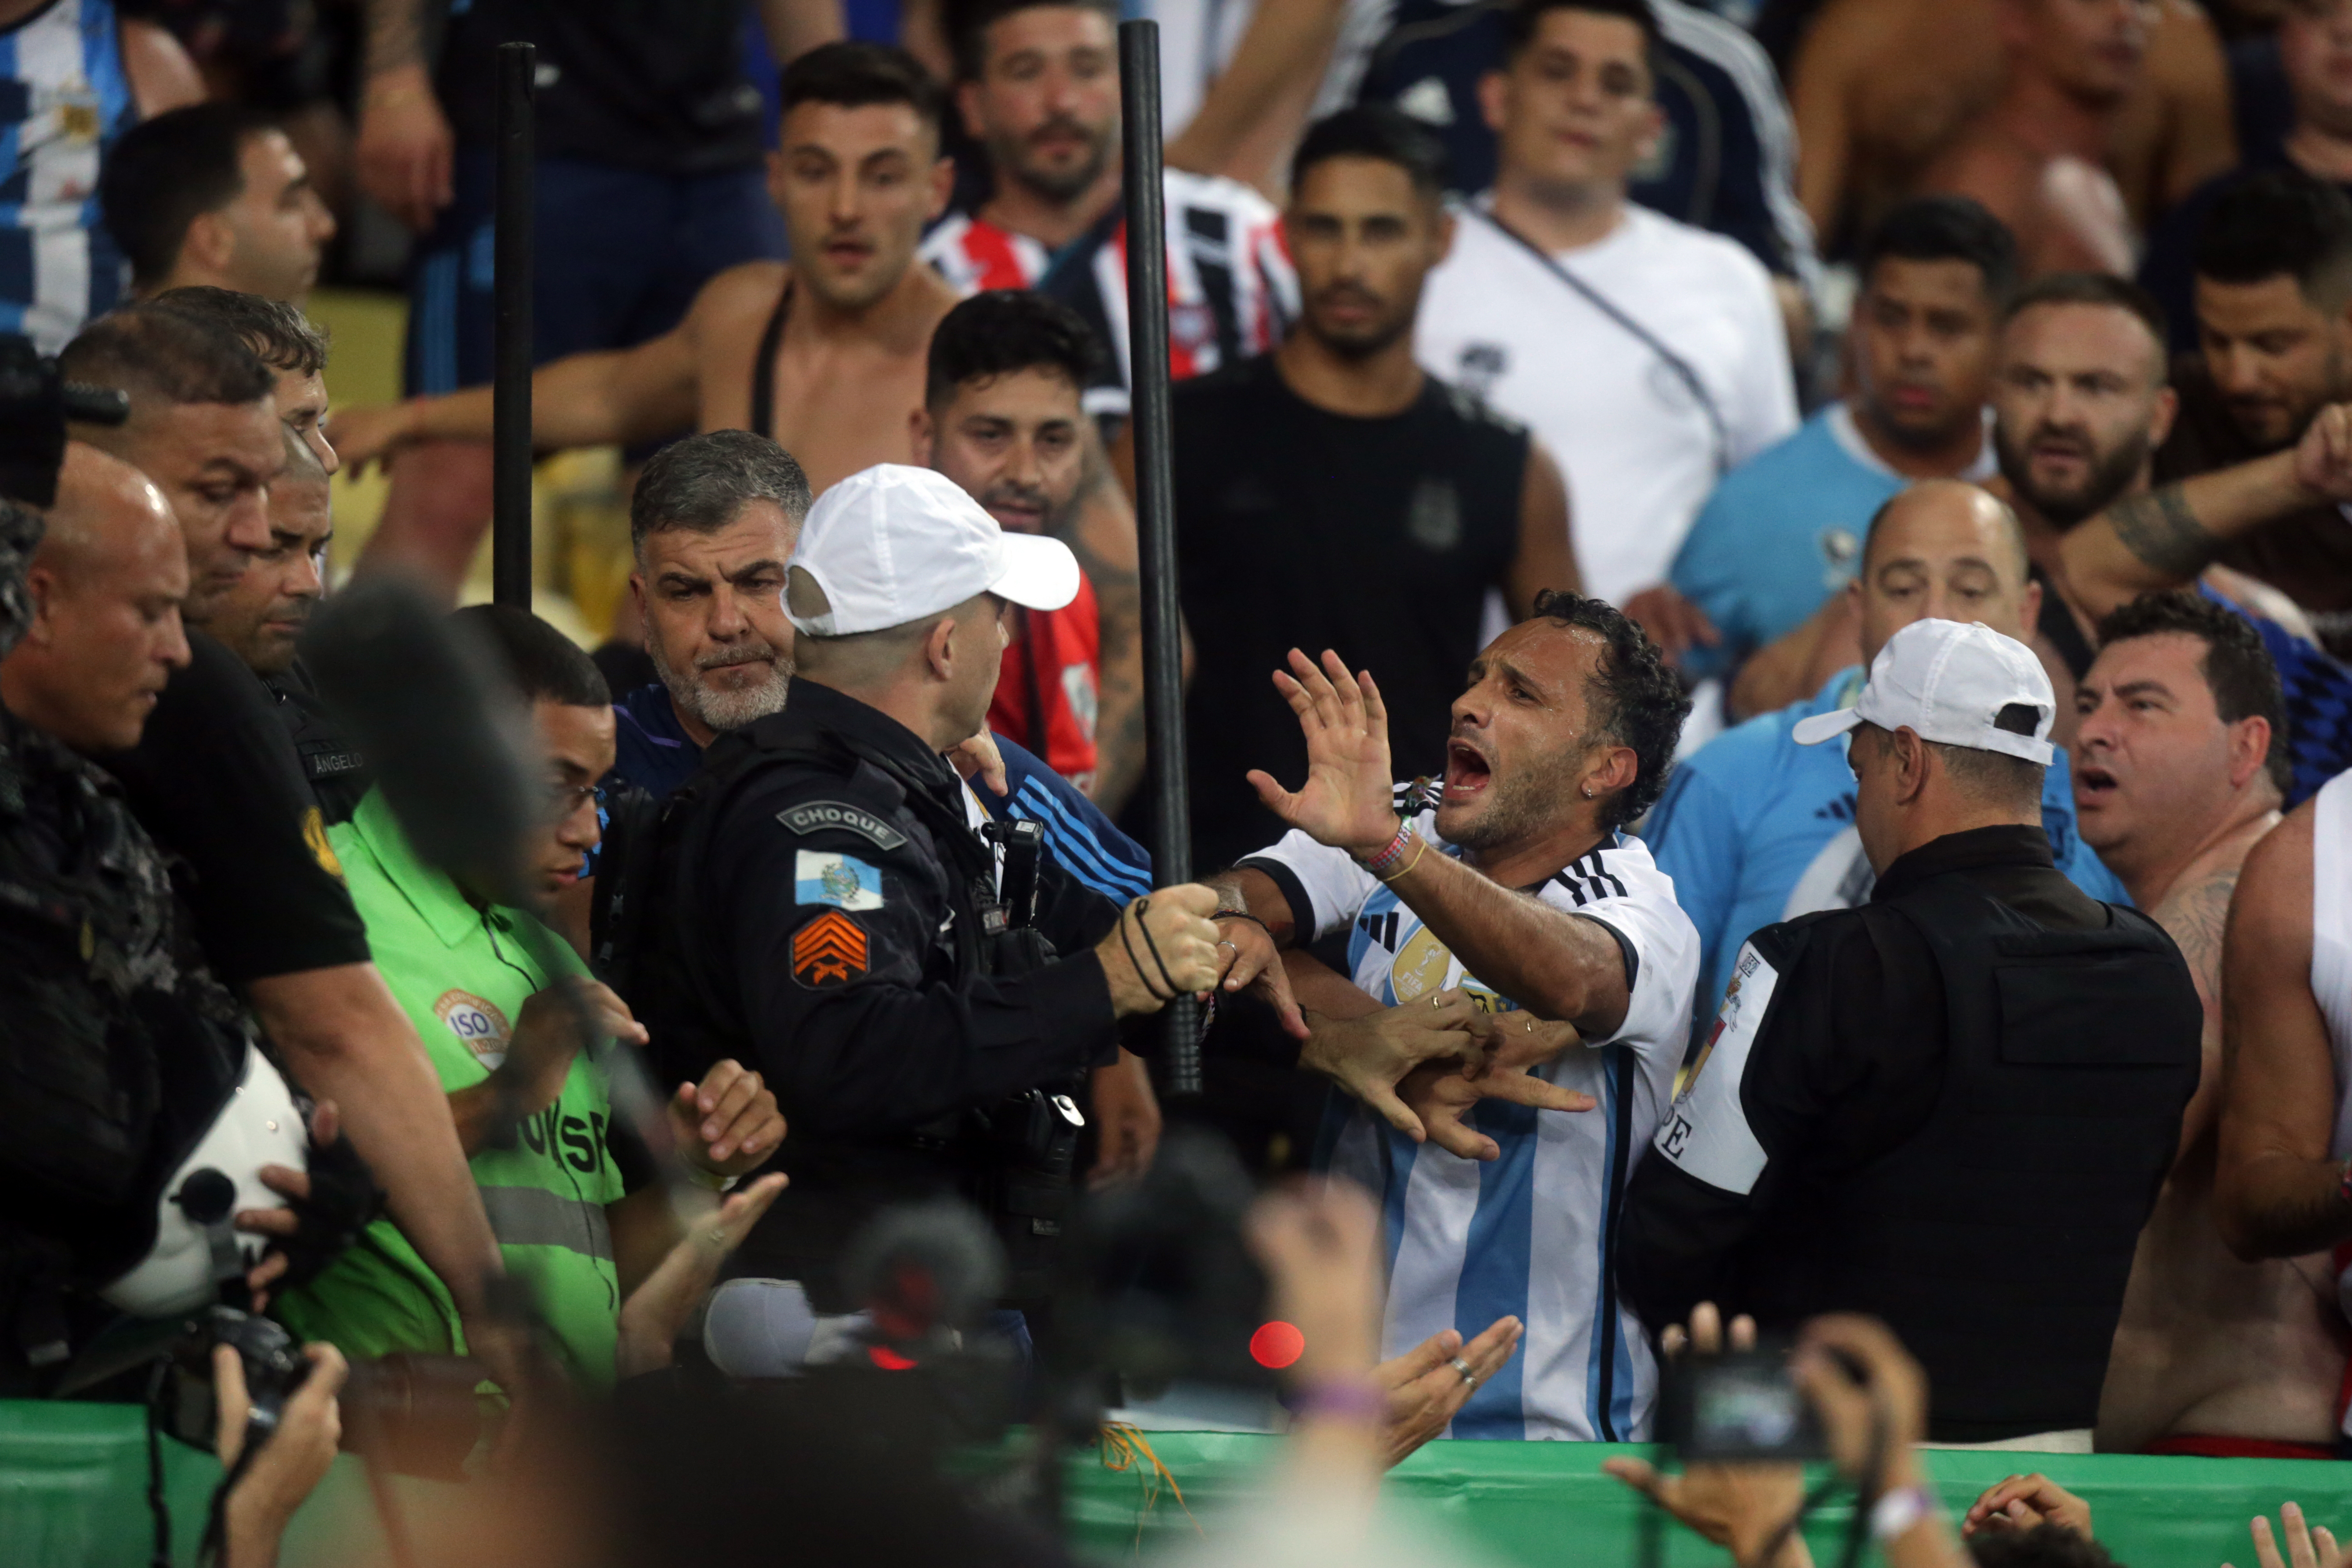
(0, 442, 188, 755)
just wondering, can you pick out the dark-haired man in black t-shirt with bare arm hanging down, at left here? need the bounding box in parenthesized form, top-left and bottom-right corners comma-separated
(61, 306, 506, 1371)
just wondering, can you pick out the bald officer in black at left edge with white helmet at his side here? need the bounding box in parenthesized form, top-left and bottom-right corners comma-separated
(0, 444, 374, 1392)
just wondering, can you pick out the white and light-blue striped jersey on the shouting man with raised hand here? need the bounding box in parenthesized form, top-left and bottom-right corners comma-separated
(1244, 797, 1698, 1441)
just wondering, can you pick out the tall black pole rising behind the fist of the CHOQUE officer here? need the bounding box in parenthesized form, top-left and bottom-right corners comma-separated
(1120, 21, 1200, 1098)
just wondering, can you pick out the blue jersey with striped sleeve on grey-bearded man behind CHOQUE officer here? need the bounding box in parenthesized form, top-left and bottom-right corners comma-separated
(604, 684, 1152, 903)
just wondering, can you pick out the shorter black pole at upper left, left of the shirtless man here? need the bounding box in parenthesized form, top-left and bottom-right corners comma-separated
(489, 44, 539, 609)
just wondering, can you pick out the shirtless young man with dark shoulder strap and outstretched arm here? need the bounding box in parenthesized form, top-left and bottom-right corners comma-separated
(334, 42, 955, 491)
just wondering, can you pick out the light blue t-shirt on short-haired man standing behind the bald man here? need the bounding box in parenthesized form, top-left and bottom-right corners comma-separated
(1667, 402, 1992, 679)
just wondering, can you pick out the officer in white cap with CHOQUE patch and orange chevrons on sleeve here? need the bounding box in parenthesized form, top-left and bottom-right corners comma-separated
(628, 463, 1230, 1309)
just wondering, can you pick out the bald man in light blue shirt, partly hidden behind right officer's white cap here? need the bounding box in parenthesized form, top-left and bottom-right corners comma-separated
(1642, 480, 2126, 1034)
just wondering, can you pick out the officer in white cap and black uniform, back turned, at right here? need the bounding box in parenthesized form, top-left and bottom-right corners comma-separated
(1618, 621, 2201, 1441)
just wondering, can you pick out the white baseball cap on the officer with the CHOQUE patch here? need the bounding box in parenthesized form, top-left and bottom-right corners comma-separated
(785, 463, 1077, 637)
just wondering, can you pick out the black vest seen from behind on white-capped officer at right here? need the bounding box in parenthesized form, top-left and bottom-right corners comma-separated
(1757, 874, 2204, 1441)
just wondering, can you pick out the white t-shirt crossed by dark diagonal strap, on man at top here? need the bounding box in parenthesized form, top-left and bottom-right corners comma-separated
(1416, 197, 1797, 604)
